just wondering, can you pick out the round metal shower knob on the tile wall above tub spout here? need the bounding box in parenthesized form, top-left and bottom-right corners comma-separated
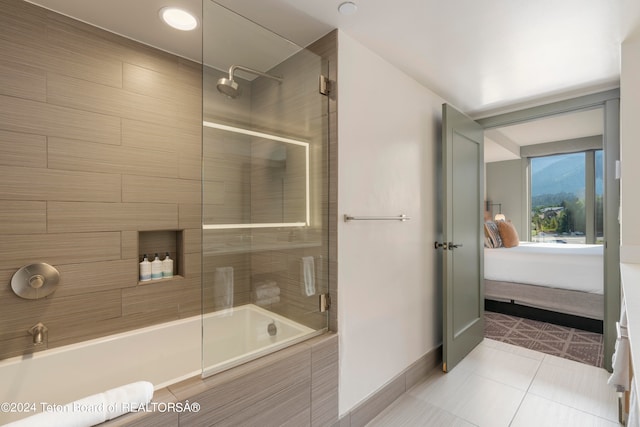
(11, 262, 60, 299)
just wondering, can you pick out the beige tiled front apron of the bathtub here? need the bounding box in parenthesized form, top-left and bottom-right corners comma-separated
(105, 334, 340, 427)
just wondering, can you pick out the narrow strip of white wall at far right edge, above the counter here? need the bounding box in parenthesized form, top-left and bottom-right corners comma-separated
(620, 32, 640, 263)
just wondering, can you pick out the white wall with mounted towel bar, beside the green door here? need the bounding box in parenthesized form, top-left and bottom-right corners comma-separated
(338, 32, 443, 415)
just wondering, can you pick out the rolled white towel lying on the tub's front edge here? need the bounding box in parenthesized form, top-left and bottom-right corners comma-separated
(6, 381, 153, 427)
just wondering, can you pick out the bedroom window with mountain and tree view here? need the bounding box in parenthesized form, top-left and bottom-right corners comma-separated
(530, 150, 604, 243)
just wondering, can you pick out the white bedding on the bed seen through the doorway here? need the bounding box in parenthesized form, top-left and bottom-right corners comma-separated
(484, 242, 604, 294)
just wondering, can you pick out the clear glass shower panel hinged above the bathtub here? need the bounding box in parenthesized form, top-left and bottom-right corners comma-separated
(202, 0, 329, 376)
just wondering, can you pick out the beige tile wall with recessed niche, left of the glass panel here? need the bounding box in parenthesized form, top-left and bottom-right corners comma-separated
(0, 0, 202, 358)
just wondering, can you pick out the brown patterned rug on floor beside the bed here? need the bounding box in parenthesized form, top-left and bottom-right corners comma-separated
(484, 311, 603, 368)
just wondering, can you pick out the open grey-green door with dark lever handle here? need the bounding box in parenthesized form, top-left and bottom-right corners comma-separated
(440, 104, 484, 372)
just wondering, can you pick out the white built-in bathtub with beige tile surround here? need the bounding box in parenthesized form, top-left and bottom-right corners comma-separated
(0, 304, 323, 425)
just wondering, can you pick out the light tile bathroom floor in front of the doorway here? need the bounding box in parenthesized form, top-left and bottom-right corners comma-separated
(368, 338, 619, 427)
